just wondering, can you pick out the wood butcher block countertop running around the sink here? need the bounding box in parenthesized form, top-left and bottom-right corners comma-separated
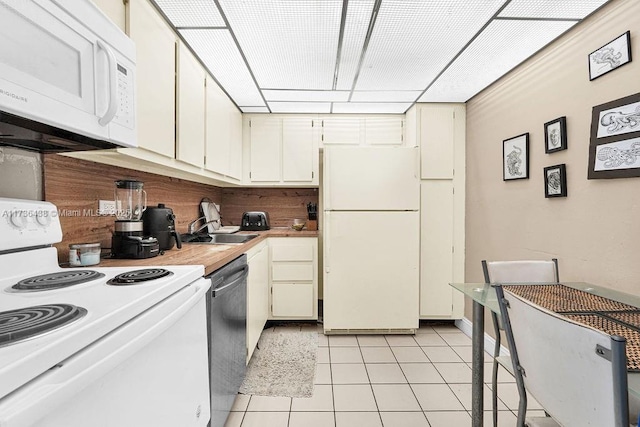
(95, 228, 318, 275)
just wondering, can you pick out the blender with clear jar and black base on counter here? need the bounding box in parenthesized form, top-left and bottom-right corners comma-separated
(111, 180, 160, 259)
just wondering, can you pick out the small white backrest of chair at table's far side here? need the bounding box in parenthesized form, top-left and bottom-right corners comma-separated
(482, 258, 560, 283)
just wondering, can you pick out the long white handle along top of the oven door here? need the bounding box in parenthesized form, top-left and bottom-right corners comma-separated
(0, 278, 210, 427)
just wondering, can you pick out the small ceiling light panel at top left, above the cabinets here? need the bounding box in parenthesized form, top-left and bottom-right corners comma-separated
(154, 0, 225, 27)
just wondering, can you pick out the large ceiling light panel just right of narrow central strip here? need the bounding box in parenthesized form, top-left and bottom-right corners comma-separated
(355, 0, 504, 90)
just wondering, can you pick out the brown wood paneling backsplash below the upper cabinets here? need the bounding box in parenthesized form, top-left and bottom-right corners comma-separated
(44, 154, 318, 262)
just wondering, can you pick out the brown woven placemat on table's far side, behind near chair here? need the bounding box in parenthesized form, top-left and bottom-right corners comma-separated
(503, 285, 637, 313)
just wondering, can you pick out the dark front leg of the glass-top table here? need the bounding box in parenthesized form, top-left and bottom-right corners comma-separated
(471, 301, 484, 427)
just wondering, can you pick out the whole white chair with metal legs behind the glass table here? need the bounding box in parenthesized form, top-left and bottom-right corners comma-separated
(482, 258, 560, 427)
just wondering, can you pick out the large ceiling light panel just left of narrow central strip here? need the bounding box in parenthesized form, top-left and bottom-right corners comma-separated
(220, 0, 342, 90)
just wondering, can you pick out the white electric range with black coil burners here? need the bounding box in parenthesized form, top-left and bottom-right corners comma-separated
(0, 198, 210, 427)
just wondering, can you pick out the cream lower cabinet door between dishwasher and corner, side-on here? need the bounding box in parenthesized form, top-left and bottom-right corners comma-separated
(247, 240, 269, 363)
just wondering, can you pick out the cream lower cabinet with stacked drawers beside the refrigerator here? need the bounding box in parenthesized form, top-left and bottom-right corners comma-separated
(269, 237, 318, 320)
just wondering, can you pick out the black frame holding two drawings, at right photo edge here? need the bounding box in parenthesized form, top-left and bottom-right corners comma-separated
(587, 93, 640, 179)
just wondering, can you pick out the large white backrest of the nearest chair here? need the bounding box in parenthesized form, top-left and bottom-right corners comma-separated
(496, 286, 629, 427)
